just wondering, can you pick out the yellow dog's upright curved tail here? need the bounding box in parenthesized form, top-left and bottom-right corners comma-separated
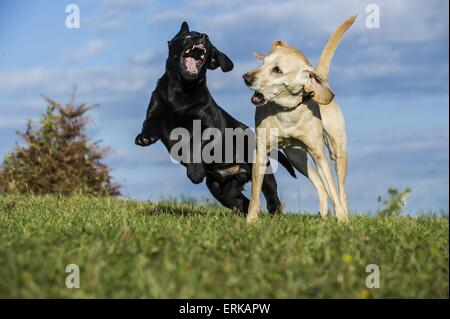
(316, 15, 357, 81)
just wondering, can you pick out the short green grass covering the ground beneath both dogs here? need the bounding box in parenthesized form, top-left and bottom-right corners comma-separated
(0, 196, 449, 298)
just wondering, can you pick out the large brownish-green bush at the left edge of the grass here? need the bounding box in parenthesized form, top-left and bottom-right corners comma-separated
(0, 96, 120, 195)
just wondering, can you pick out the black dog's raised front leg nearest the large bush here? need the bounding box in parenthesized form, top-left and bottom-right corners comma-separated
(134, 93, 164, 146)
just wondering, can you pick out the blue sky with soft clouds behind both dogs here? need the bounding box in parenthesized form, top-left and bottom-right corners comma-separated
(0, 0, 449, 213)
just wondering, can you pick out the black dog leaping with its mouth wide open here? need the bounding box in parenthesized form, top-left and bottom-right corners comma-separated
(135, 22, 295, 213)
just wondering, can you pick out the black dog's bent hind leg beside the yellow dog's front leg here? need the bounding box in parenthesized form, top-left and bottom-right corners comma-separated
(206, 177, 250, 215)
